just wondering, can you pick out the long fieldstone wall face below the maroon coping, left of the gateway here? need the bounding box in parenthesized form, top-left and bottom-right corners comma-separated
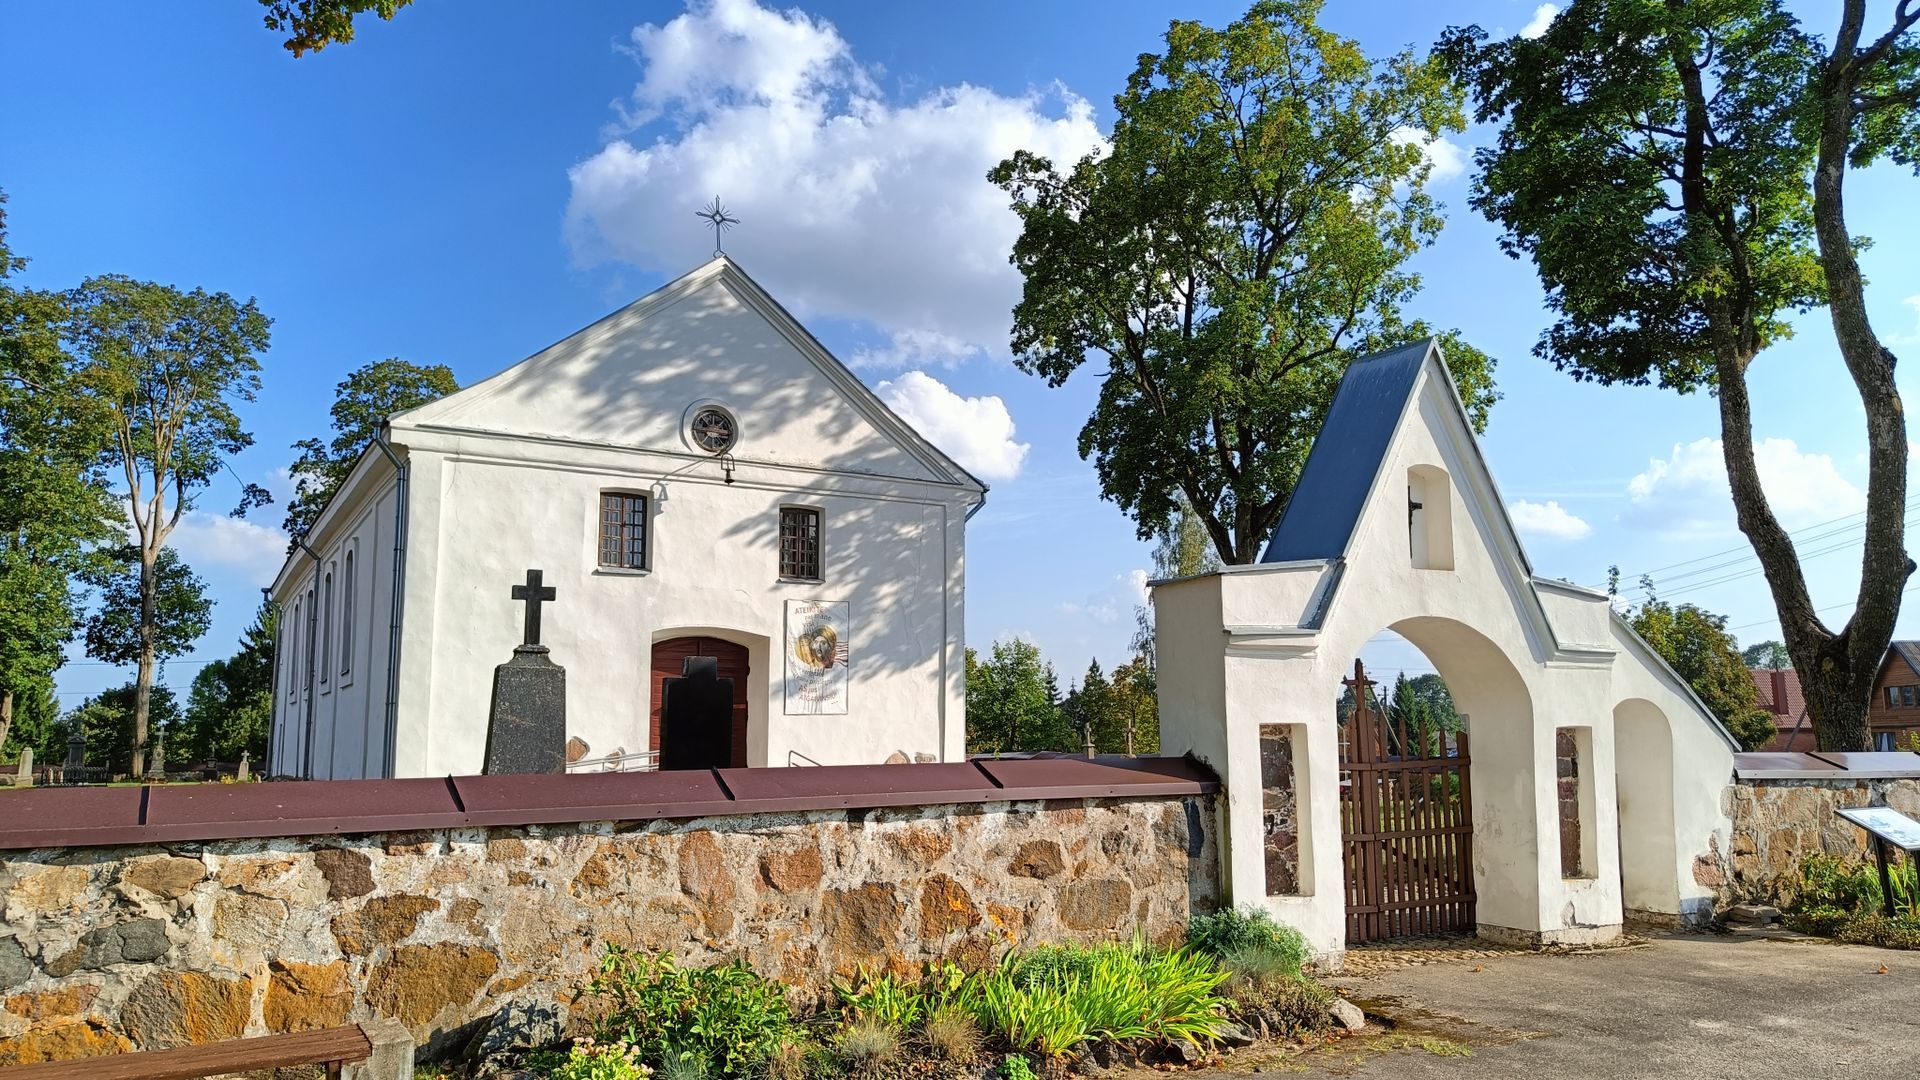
(0, 796, 1219, 1067)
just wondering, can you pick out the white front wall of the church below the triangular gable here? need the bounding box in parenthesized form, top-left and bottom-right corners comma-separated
(396, 432, 966, 776)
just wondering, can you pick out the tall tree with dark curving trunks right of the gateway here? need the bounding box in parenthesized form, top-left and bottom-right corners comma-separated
(1438, 0, 1920, 749)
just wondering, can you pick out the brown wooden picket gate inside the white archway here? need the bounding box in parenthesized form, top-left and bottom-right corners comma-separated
(1340, 661, 1475, 944)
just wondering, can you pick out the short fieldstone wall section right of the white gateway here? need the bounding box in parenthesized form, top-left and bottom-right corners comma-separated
(1693, 776, 1920, 907)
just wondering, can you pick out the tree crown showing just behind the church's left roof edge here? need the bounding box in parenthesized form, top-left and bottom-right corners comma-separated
(286, 357, 461, 536)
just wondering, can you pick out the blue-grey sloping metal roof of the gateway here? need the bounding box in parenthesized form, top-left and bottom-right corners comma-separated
(1260, 338, 1434, 563)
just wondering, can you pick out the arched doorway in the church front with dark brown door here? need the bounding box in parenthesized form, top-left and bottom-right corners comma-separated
(647, 636, 751, 769)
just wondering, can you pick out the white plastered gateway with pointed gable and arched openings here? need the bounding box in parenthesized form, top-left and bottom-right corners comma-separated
(1154, 359, 1732, 955)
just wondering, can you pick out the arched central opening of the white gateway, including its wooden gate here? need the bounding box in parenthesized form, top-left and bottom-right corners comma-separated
(1336, 617, 1536, 944)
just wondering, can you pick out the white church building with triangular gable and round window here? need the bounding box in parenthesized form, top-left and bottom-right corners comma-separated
(269, 256, 987, 780)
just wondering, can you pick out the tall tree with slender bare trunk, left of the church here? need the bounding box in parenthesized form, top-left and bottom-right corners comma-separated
(67, 275, 271, 776)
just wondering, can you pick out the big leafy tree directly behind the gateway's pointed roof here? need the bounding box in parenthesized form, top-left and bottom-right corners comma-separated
(991, 0, 1496, 563)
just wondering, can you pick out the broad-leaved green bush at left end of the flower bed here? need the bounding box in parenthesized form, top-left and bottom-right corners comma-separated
(588, 945, 795, 1080)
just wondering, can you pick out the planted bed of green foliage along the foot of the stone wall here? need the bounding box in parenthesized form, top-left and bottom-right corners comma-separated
(510, 913, 1332, 1080)
